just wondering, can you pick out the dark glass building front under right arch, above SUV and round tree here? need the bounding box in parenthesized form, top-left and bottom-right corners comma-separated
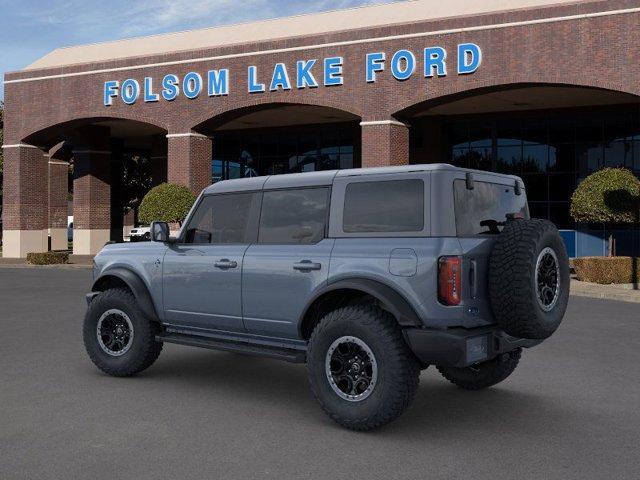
(444, 106, 640, 228)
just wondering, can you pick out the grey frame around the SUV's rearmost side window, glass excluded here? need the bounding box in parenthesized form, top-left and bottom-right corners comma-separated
(329, 171, 432, 238)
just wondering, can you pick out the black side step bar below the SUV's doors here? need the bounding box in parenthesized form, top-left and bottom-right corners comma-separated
(156, 333, 307, 363)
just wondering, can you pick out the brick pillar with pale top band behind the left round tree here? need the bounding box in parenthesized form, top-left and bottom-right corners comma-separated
(167, 133, 213, 195)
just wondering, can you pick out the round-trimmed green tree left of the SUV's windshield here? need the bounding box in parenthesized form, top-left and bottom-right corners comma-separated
(139, 183, 196, 225)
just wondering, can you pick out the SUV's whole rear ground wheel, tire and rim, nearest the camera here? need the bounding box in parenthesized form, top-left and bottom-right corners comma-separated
(307, 305, 420, 431)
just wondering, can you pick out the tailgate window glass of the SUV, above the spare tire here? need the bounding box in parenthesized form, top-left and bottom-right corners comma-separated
(453, 180, 529, 237)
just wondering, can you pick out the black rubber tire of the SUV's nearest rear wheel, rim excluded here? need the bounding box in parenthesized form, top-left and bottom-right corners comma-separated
(307, 304, 420, 431)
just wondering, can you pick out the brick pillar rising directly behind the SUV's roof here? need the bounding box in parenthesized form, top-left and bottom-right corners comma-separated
(360, 120, 409, 168)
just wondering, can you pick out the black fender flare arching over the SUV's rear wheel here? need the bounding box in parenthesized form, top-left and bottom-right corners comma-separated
(299, 278, 423, 327)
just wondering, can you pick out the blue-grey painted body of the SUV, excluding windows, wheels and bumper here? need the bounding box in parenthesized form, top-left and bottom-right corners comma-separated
(95, 165, 524, 345)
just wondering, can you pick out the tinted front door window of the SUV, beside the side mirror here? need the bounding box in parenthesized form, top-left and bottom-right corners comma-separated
(185, 193, 260, 245)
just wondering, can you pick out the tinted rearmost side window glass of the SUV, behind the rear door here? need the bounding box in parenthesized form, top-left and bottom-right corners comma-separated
(342, 179, 425, 233)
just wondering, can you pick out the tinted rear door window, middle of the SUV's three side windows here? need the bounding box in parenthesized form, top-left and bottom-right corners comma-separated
(258, 188, 329, 244)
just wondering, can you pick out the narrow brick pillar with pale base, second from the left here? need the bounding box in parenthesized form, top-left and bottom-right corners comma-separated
(49, 158, 69, 250)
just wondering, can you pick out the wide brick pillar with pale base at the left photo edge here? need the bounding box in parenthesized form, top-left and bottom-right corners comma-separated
(2, 144, 49, 258)
